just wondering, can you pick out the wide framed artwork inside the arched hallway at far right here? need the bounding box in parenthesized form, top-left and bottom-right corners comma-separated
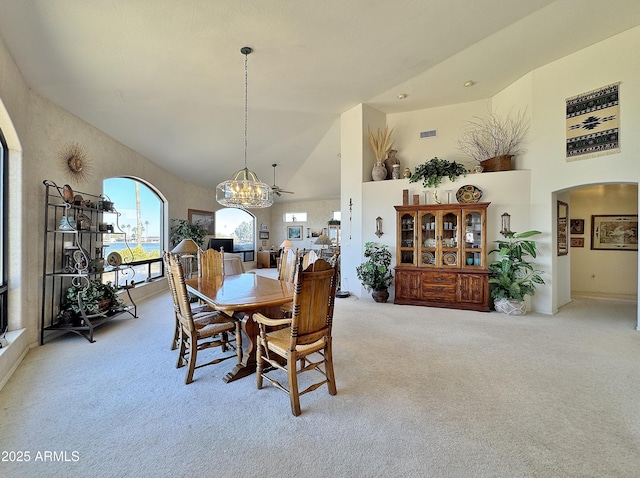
(591, 214, 638, 251)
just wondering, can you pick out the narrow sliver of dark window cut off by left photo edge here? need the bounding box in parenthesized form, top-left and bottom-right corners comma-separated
(0, 130, 9, 335)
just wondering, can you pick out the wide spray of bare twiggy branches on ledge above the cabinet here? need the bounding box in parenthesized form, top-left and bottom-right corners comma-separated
(458, 110, 529, 162)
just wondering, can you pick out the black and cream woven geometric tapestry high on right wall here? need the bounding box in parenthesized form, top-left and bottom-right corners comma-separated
(566, 83, 620, 161)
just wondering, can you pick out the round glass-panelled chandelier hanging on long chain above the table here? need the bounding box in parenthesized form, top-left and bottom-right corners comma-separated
(216, 46, 273, 209)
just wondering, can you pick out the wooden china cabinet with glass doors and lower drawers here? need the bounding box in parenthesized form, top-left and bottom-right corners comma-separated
(394, 202, 490, 311)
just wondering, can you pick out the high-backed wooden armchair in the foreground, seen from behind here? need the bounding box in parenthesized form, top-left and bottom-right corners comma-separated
(253, 258, 337, 416)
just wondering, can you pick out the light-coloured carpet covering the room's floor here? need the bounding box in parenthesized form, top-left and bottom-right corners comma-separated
(0, 270, 640, 478)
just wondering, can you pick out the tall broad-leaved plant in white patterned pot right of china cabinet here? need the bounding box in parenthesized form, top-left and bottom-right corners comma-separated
(489, 231, 544, 315)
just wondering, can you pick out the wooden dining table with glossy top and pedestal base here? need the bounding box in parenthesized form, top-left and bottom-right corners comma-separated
(185, 273, 294, 383)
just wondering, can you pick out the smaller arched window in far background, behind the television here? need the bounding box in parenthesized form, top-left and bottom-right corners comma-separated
(215, 207, 256, 262)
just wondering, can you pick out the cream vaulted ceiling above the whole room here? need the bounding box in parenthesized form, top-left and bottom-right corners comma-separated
(0, 0, 640, 200)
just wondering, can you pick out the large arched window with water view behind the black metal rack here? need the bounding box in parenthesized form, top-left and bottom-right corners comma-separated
(102, 178, 165, 286)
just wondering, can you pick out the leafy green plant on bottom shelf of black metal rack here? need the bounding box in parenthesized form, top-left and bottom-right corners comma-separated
(58, 279, 123, 324)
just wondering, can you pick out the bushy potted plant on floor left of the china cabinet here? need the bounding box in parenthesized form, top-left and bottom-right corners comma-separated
(356, 242, 393, 302)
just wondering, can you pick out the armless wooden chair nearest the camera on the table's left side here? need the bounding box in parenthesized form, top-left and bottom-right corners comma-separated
(169, 254, 242, 384)
